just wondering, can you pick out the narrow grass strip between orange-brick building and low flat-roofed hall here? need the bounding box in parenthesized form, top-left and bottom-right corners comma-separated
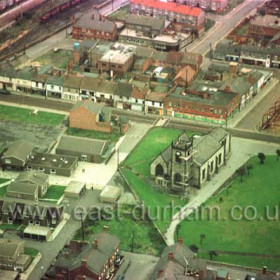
(66, 128, 122, 143)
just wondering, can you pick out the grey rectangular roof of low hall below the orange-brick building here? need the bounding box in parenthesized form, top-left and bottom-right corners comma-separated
(56, 135, 107, 155)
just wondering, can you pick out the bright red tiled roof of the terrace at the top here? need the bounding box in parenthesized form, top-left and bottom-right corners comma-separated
(130, 0, 202, 17)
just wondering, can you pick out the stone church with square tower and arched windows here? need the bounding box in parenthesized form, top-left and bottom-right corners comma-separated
(150, 128, 231, 192)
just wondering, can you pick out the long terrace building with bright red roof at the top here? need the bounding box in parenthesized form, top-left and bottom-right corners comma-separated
(130, 0, 205, 30)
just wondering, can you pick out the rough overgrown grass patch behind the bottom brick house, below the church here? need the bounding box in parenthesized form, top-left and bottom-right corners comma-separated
(75, 207, 166, 256)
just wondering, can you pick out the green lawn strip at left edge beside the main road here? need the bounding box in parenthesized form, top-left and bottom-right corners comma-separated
(0, 105, 65, 126)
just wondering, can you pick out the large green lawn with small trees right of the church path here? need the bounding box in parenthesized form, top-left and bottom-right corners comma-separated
(180, 156, 280, 269)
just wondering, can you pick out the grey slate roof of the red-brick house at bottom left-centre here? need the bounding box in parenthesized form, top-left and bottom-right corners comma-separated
(54, 232, 120, 274)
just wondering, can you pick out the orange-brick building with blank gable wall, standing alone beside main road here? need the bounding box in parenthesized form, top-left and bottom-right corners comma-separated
(69, 99, 111, 132)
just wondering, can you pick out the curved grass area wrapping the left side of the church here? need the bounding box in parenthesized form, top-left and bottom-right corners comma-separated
(122, 128, 196, 232)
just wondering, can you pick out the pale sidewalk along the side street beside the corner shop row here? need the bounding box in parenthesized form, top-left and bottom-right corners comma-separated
(227, 78, 279, 128)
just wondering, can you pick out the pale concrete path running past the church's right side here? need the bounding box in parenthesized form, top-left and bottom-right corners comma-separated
(165, 137, 280, 245)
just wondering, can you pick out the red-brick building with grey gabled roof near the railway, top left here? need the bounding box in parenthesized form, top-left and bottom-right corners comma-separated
(72, 10, 118, 41)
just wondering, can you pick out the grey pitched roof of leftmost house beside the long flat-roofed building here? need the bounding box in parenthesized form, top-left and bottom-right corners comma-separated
(2, 140, 34, 161)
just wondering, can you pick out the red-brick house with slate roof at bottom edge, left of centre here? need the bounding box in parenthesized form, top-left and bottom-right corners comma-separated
(47, 227, 121, 280)
